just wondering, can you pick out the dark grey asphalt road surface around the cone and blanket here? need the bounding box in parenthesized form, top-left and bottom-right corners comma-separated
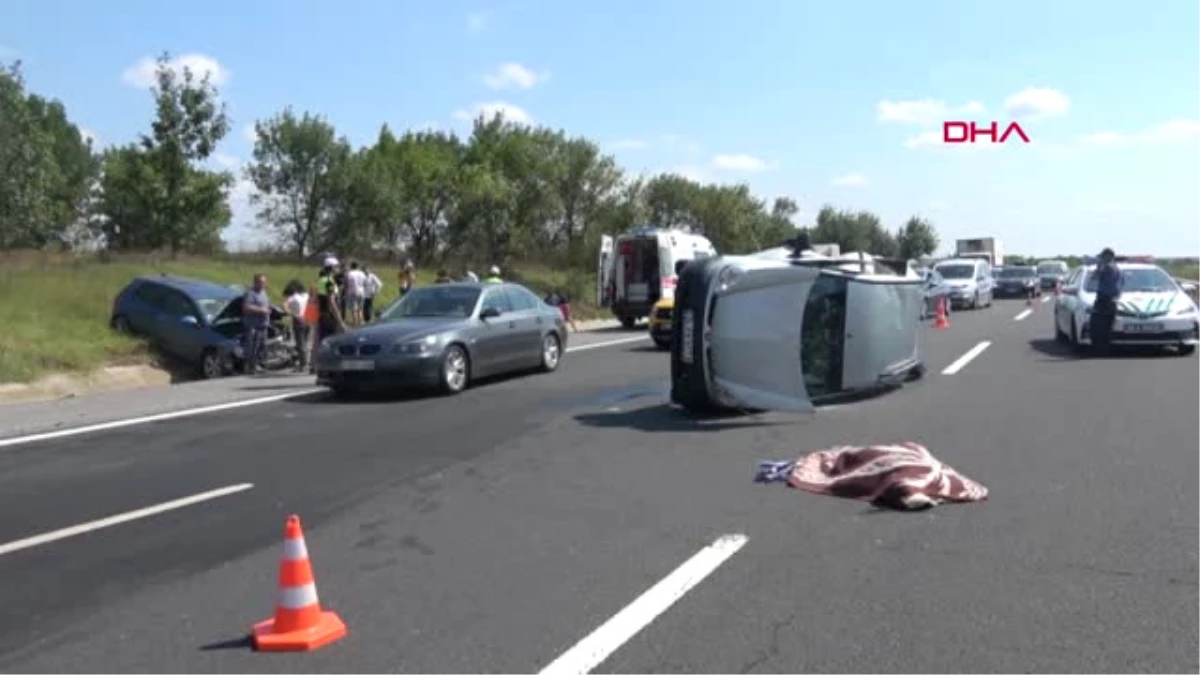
(0, 301, 1200, 675)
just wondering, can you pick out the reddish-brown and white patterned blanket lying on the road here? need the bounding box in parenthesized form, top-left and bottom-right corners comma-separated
(755, 443, 988, 510)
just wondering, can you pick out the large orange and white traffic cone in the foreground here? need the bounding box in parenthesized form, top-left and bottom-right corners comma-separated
(253, 515, 347, 651)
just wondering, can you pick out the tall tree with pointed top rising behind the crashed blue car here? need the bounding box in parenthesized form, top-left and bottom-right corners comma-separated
(98, 54, 233, 253)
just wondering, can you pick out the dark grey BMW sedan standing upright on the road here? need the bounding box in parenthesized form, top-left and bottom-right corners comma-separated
(316, 282, 566, 394)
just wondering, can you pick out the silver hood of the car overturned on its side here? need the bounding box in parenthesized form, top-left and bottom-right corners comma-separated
(708, 261, 820, 412)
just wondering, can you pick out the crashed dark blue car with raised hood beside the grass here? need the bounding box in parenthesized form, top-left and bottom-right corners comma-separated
(109, 275, 295, 378)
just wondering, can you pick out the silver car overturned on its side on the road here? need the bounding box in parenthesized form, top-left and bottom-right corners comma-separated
(671, 241, 924, 412)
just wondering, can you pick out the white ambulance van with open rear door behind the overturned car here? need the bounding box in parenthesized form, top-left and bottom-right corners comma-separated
(596, 227, 716, 328)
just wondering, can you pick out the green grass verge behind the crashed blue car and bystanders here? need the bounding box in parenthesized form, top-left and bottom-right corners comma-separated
(0, 253, 604, 383)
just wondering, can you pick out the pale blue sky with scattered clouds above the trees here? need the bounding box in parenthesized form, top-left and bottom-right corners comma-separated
(7, 0, 1200, 256)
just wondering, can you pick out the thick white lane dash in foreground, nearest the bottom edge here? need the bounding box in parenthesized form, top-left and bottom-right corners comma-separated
(538, 534, 748, 675)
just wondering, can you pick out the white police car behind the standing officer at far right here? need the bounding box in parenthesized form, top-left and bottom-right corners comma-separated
(1054, 256, 1200, 356)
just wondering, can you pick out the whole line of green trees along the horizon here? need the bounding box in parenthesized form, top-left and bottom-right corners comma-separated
(0, 54, 938, 270)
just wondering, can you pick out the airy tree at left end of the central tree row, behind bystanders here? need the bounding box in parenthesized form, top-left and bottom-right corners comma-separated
(246, 108, 350, 258)
